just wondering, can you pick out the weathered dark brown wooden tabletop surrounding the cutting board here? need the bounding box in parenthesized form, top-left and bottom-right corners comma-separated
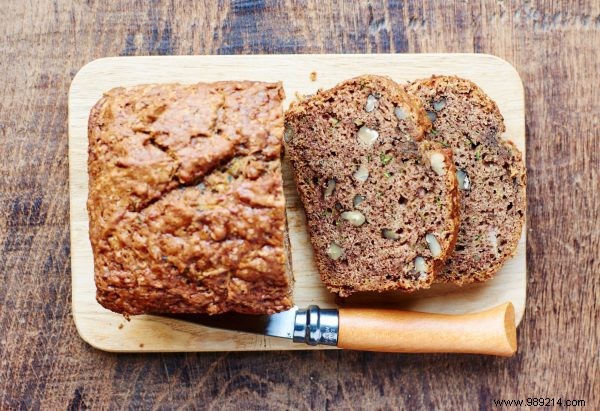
(0, 0, 600, 409)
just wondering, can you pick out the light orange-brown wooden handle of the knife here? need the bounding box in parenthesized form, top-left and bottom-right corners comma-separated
(337, 303, 517, 357)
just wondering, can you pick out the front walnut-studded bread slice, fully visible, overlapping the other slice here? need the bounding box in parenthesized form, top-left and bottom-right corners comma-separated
(284, 76, 458, 297)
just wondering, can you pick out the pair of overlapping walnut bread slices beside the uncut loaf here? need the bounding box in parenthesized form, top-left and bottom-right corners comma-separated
(284, 75, 525, 297)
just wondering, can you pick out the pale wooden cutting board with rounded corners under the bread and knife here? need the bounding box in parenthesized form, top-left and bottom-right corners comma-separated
(69, 54, 527, 352)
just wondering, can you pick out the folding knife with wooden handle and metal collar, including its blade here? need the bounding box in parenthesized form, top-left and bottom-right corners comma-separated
(169, 302, 517, 357)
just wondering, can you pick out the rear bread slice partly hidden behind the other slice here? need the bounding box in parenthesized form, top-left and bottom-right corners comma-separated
(406, 76, 526, 284)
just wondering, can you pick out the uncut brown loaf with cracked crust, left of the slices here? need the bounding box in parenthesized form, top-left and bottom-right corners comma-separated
(87, 82, 292, 315)
